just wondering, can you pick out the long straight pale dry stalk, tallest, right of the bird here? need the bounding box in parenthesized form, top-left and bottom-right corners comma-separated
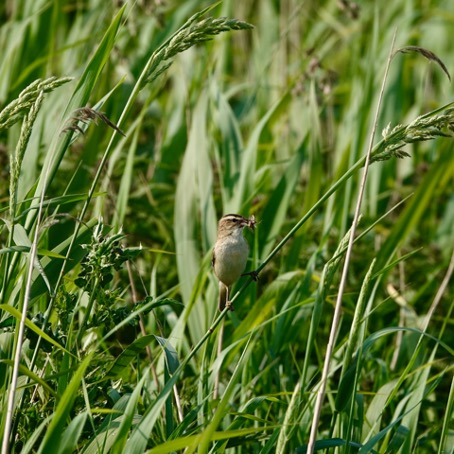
(307, 32, 396, 454)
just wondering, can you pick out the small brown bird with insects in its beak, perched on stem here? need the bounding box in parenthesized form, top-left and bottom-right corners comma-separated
(212, 214, 256, 311)
